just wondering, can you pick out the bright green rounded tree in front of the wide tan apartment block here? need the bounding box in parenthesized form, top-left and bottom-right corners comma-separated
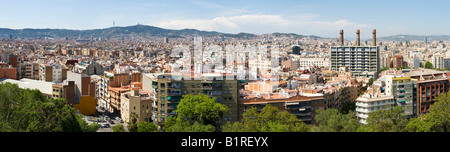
(164, 93, 230, 132)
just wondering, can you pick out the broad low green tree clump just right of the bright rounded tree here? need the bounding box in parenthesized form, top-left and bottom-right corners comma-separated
(223, 104, 311, 132)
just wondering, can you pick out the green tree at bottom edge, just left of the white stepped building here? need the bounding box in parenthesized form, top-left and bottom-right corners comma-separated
(313, 109, 359, 132)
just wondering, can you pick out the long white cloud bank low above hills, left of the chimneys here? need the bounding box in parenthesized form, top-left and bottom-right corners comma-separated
(156, 14, 371, 37)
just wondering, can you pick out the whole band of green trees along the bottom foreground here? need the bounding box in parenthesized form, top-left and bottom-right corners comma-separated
(0, 83, 450, 132)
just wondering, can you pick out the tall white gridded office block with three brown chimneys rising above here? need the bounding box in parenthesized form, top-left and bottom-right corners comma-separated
(330, 30, 380, 78)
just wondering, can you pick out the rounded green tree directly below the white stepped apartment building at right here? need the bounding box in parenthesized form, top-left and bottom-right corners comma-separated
(367, 106, 408, 132)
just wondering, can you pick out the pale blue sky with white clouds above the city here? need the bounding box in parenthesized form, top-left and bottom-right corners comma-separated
(0, 0, 450, 39)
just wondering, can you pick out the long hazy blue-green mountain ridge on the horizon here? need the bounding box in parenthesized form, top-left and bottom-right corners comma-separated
(0, 24, 321, 39)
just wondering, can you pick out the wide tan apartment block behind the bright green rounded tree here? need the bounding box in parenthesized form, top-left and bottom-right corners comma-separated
(147, 73, 240, 124)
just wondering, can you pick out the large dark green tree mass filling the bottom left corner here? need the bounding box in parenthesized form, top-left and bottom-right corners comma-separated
(0, 83, 91, 132)
